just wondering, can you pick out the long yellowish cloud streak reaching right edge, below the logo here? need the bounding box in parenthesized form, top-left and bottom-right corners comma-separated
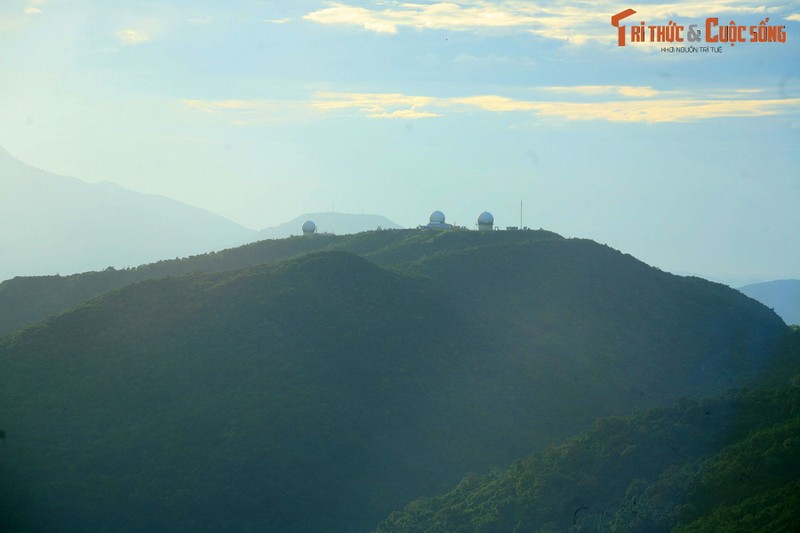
(181, 85, 800, 125)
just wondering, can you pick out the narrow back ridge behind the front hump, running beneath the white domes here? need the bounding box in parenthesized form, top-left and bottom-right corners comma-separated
(0, 230, 561, 336)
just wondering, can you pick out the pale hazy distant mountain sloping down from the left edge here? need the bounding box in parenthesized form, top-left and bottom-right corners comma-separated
(0, 143, 256, 280)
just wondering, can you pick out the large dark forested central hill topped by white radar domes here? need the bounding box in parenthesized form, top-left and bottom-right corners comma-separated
(0, 230, 797, 532)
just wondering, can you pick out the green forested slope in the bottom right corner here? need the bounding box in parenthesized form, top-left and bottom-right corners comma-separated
(376, 370, 800, 533)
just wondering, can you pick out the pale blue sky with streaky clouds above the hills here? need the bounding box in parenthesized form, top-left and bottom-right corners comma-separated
(0, 0, 800, 284)
